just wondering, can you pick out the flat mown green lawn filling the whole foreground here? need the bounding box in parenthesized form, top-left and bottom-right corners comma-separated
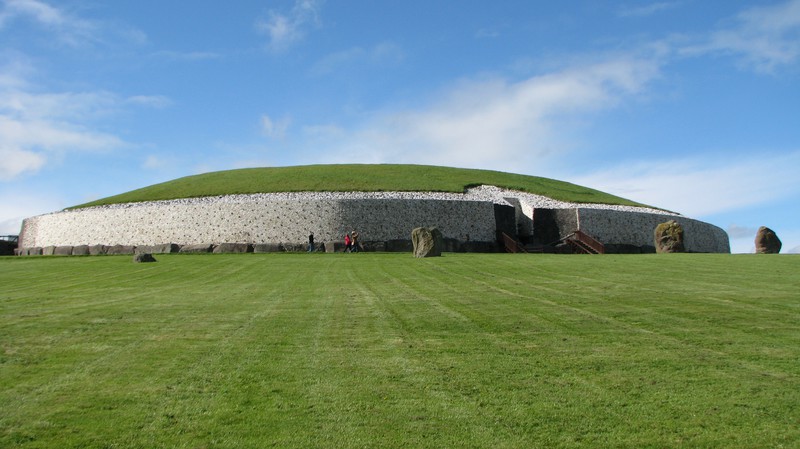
(0, 253, 800, 448)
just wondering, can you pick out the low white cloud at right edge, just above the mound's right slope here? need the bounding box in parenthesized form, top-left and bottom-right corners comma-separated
(568, 151, 800, 217)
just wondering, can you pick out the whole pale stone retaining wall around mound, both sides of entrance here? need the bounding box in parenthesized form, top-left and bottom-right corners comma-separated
(18, 187, 730, 255)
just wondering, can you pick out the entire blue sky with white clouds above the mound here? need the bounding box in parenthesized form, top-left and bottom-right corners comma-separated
(0, 0, 800, 253)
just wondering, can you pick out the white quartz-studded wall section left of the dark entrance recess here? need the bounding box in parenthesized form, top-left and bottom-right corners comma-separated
(20, 198, 495, 248)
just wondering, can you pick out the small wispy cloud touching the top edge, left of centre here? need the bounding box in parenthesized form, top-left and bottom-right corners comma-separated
(256, 0, 323, 52)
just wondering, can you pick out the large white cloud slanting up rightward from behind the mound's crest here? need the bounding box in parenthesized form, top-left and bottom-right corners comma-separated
(310, 58, 659, 170)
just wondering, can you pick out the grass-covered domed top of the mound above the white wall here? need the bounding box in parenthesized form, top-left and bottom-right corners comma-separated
(70, 164, 641, 208)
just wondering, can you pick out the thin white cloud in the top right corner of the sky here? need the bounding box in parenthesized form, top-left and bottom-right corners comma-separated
(681, 0, 800, 73)
